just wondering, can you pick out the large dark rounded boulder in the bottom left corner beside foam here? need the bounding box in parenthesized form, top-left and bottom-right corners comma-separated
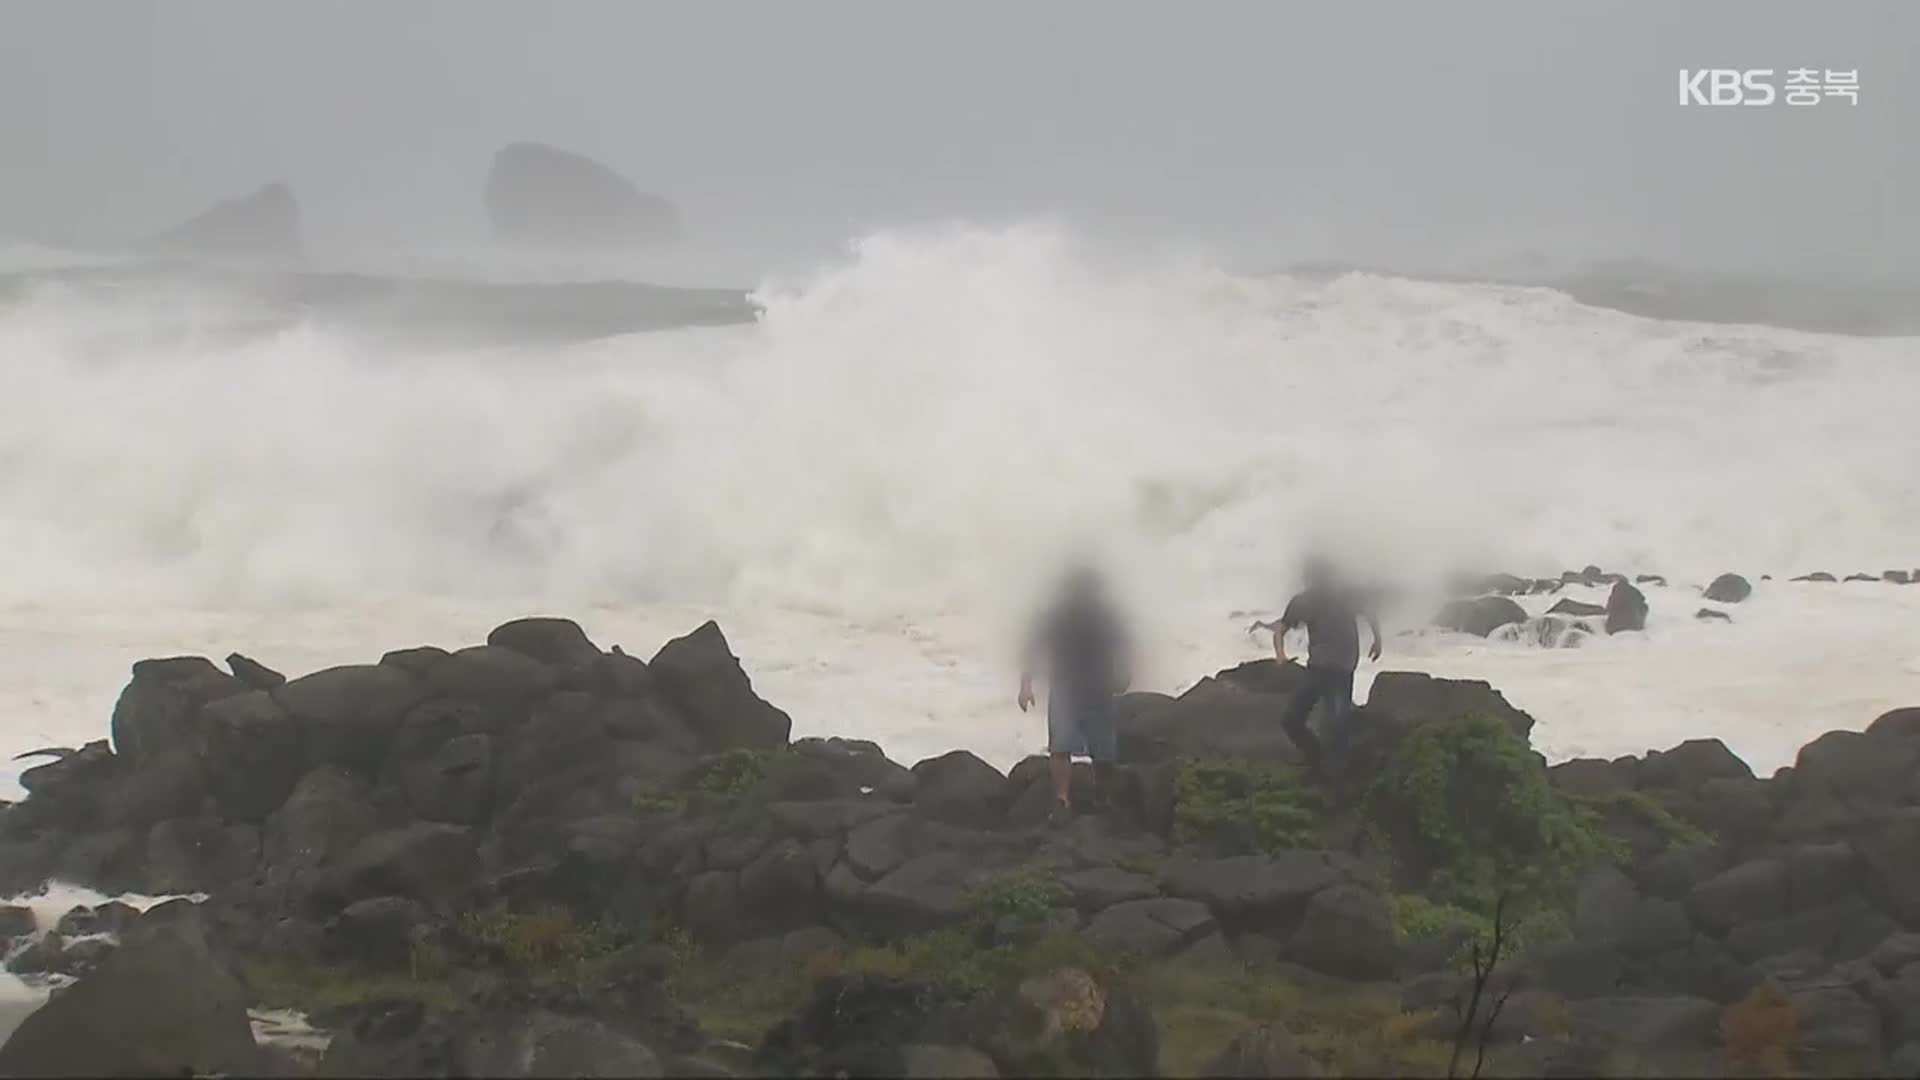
(0, 919, 257, 1076)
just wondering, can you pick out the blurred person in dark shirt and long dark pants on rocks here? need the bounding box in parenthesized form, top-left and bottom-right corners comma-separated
(1271, 559, 1380, 769)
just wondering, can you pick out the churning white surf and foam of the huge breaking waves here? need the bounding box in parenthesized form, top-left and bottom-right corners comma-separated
(0, 220, 1920, 799)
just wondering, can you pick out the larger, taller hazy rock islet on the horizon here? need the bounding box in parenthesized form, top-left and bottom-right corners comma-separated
(484, 142, 682, 248)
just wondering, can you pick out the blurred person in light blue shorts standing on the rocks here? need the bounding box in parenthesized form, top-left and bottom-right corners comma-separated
(1020, 567, 1129, 821)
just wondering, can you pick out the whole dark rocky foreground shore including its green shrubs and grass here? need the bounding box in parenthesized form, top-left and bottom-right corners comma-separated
(0, 618, 1920, 1076)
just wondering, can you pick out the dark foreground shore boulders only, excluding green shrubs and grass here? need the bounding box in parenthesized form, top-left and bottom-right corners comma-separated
(0, 618, 1920, 1076)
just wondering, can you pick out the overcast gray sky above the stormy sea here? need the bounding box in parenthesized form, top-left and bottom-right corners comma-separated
(0, 0, 1920, 277)
